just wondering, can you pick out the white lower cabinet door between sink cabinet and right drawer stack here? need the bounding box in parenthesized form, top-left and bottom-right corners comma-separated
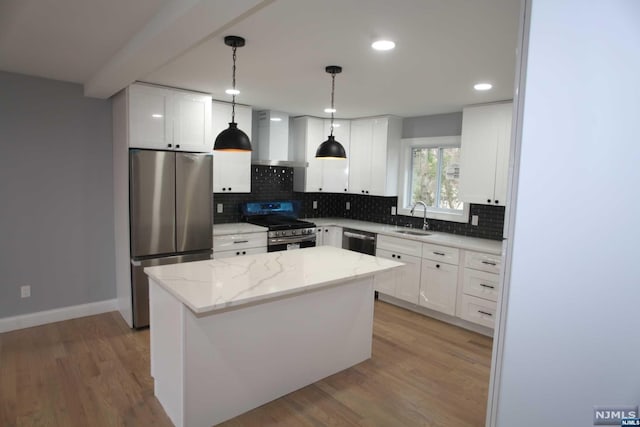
(420, 259, 458, 316)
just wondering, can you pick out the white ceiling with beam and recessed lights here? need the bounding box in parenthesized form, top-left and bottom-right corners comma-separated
(0, 0, 521, 118)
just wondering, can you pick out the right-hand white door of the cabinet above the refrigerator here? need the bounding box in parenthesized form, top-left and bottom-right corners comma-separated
(172, 92, 214, 153)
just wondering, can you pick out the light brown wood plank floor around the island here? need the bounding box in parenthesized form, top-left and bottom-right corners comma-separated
(0, 301, 491, 427)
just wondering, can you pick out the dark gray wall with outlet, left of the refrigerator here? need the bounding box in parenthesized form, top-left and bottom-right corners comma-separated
(0, 72, 115, 318)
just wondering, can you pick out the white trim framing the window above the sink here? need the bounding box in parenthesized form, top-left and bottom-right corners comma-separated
(397, 135, 469, 223)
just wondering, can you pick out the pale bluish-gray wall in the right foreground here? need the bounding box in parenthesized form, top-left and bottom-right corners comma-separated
(496, 0, 640, 427)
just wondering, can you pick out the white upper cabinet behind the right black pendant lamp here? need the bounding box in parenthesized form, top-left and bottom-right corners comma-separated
(293, 117, 351, 193)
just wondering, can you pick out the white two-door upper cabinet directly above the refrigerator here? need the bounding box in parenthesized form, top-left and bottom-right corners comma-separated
(129, 84, 213, 152)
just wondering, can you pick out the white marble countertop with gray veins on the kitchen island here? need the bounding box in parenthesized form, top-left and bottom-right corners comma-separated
(144, 246, 403, 314)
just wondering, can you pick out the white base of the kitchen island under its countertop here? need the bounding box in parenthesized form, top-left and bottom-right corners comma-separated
(149, 276, 374, 427)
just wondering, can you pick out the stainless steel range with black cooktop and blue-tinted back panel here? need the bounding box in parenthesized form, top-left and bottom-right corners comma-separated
(242, 200, 316, 252)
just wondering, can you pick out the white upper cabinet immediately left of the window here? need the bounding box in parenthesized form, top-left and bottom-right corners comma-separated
(349, 117, 402, 196)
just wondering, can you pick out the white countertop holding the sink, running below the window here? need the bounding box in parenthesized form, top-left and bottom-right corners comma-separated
(312, 218, 502, 255)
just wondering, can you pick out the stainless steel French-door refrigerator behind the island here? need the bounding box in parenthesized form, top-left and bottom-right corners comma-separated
(129, 149, 213, 328)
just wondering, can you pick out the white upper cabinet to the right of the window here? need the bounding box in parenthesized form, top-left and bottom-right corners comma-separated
(460, 102, 513, 206)
